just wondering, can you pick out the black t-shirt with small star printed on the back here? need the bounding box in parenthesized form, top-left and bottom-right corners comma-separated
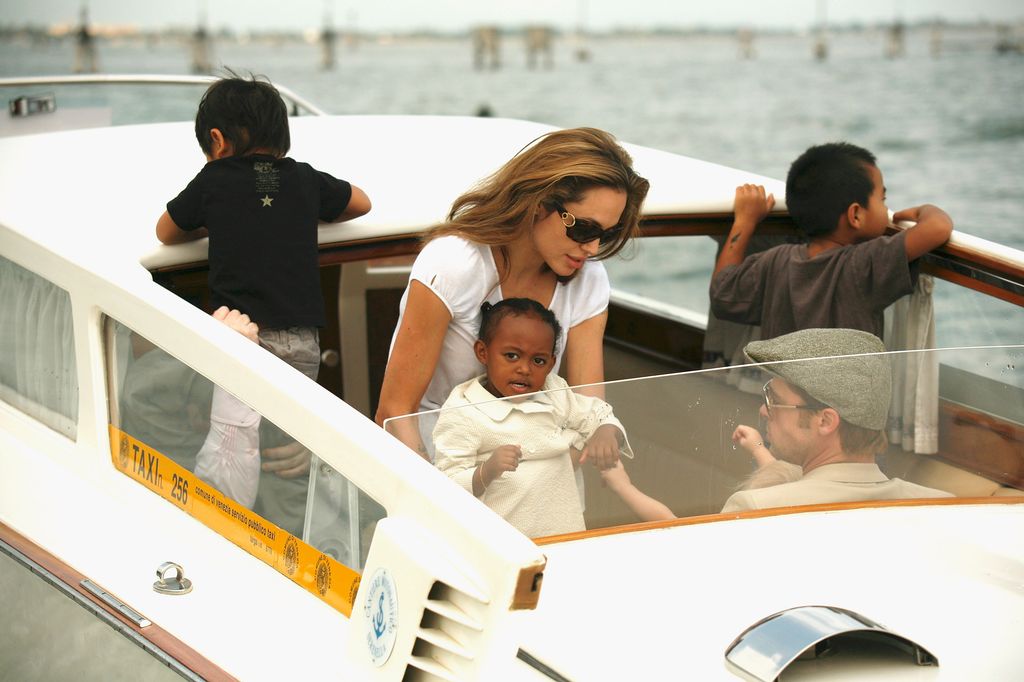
(167, 155, 352, 329)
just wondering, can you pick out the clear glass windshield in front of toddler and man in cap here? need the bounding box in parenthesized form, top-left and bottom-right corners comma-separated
(386, 346, 1024, 538)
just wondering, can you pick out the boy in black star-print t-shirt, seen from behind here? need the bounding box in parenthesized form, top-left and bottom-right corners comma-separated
(157, 76, 370, 381)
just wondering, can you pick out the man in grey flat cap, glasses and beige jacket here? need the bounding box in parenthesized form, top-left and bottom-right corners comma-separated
(722, 329, 951, 512)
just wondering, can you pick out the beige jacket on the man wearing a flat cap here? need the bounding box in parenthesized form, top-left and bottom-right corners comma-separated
(722, 462, 952, 512)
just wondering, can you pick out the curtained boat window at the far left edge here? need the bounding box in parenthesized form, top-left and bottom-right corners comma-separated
(0, 256, 78, 438)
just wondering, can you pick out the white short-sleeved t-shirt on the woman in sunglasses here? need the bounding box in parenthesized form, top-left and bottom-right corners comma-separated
(391, 236, 611, 411)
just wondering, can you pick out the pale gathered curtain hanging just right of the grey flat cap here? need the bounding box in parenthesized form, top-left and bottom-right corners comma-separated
(885, 274, 939, 455)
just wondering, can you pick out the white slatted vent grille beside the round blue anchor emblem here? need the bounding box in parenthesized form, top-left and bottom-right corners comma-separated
(402, 582, 486, 682)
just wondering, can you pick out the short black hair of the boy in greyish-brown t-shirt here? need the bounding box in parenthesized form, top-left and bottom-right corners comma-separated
(785, 142, 876, 238)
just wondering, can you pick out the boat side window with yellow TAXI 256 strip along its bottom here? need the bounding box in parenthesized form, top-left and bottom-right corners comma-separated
(104, 318, 386, 614)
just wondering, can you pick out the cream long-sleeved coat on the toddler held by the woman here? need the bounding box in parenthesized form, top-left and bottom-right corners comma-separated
(433, 373, 633, 538)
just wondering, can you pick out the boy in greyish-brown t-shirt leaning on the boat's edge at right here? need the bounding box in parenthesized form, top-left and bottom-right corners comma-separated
(711, 142, 952, 339)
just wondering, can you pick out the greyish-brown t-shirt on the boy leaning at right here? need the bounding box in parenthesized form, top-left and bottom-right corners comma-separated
(711, 231, 918, 339)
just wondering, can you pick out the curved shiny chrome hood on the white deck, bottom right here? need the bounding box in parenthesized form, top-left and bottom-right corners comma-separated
(725, 606, 939, 682)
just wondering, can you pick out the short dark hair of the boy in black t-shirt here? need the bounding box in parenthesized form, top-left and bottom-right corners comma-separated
(196, 72, 292, 157)
